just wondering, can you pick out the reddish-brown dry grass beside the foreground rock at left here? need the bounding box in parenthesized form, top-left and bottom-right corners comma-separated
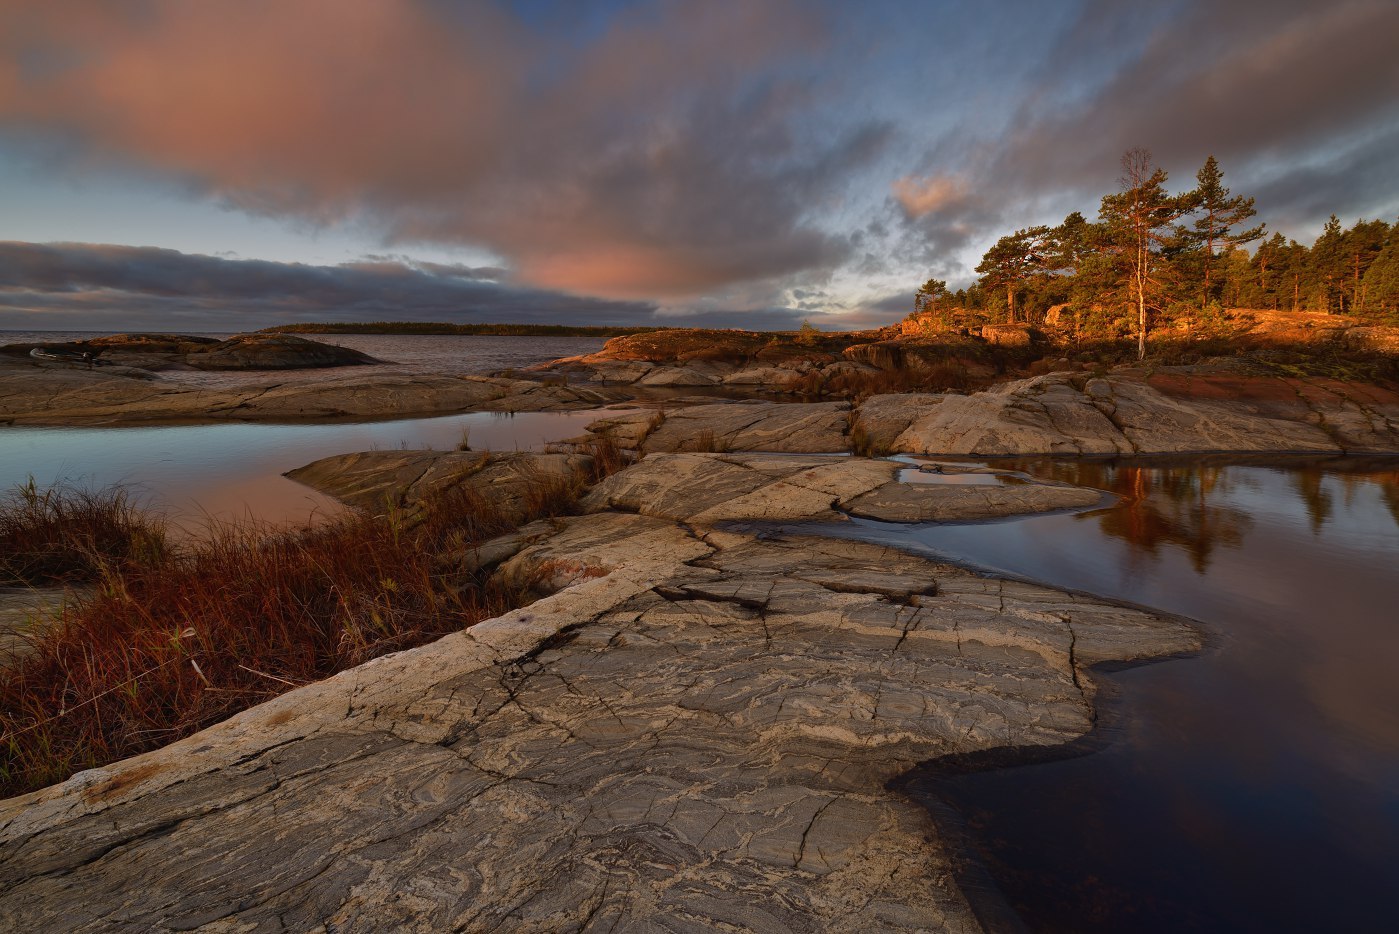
(0, 442, 625, 796)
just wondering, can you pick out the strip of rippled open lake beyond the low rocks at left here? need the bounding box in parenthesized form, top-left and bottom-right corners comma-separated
(0, 331, 604, 386)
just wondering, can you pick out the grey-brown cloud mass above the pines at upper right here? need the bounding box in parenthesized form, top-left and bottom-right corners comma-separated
(891, 0, 1399, 280)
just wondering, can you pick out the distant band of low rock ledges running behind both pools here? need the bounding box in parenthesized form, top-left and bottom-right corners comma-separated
(8, 331, 1399, 456)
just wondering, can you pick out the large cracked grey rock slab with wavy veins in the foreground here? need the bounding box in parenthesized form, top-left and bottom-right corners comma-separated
(0, 456, 1198, 931)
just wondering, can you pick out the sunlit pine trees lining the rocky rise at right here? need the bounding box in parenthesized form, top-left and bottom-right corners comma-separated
(915, 148, 1399, 355)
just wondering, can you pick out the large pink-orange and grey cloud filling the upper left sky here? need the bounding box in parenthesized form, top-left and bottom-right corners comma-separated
(0, 0, 886, 298)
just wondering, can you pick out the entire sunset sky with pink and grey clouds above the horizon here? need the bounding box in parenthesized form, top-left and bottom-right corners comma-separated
(0, 0, 1399, 330)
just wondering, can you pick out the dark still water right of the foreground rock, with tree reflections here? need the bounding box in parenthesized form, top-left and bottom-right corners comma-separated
(811, 461, 1399, 931)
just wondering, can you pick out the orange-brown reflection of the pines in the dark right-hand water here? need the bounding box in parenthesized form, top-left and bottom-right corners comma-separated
(1016, 457, 1399, 575)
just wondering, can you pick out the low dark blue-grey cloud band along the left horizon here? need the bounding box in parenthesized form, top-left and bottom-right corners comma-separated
(0, 240, 828, 331)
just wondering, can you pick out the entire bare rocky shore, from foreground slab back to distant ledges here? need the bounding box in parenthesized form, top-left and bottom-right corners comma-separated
(0, 324, 1399, 931)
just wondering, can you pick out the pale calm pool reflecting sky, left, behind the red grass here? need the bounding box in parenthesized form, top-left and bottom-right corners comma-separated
(0, 411, 623, 531)
